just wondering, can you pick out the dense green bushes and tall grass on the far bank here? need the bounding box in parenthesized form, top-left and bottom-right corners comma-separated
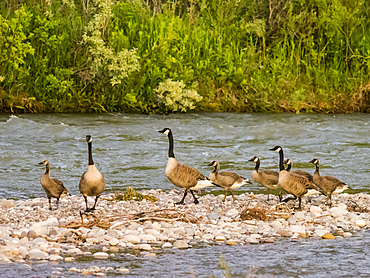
(0, 0, 370, 113)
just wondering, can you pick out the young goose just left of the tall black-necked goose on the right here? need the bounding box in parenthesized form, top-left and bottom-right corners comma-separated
(248, 156, 281, 202)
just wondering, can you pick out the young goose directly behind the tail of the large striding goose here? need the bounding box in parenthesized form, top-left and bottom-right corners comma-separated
(208, 160, 251, 202)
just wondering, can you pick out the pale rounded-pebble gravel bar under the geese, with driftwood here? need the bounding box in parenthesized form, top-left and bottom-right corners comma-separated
(0, 190, 370, 276)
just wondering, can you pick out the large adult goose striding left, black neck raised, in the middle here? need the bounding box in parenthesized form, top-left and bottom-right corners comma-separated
(158, 128, 214, 204)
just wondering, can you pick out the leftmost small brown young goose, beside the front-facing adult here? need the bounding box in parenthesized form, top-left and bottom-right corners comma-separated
(39, 160, 71, 210)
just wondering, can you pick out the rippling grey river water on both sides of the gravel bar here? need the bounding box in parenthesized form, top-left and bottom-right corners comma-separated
(0, 113, 370, 277)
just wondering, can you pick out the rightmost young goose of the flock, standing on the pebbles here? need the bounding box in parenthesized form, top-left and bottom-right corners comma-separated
(309, 158, 348, 206)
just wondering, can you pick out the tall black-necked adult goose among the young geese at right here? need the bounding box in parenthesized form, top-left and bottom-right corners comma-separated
(270, 146, 311, 209)
